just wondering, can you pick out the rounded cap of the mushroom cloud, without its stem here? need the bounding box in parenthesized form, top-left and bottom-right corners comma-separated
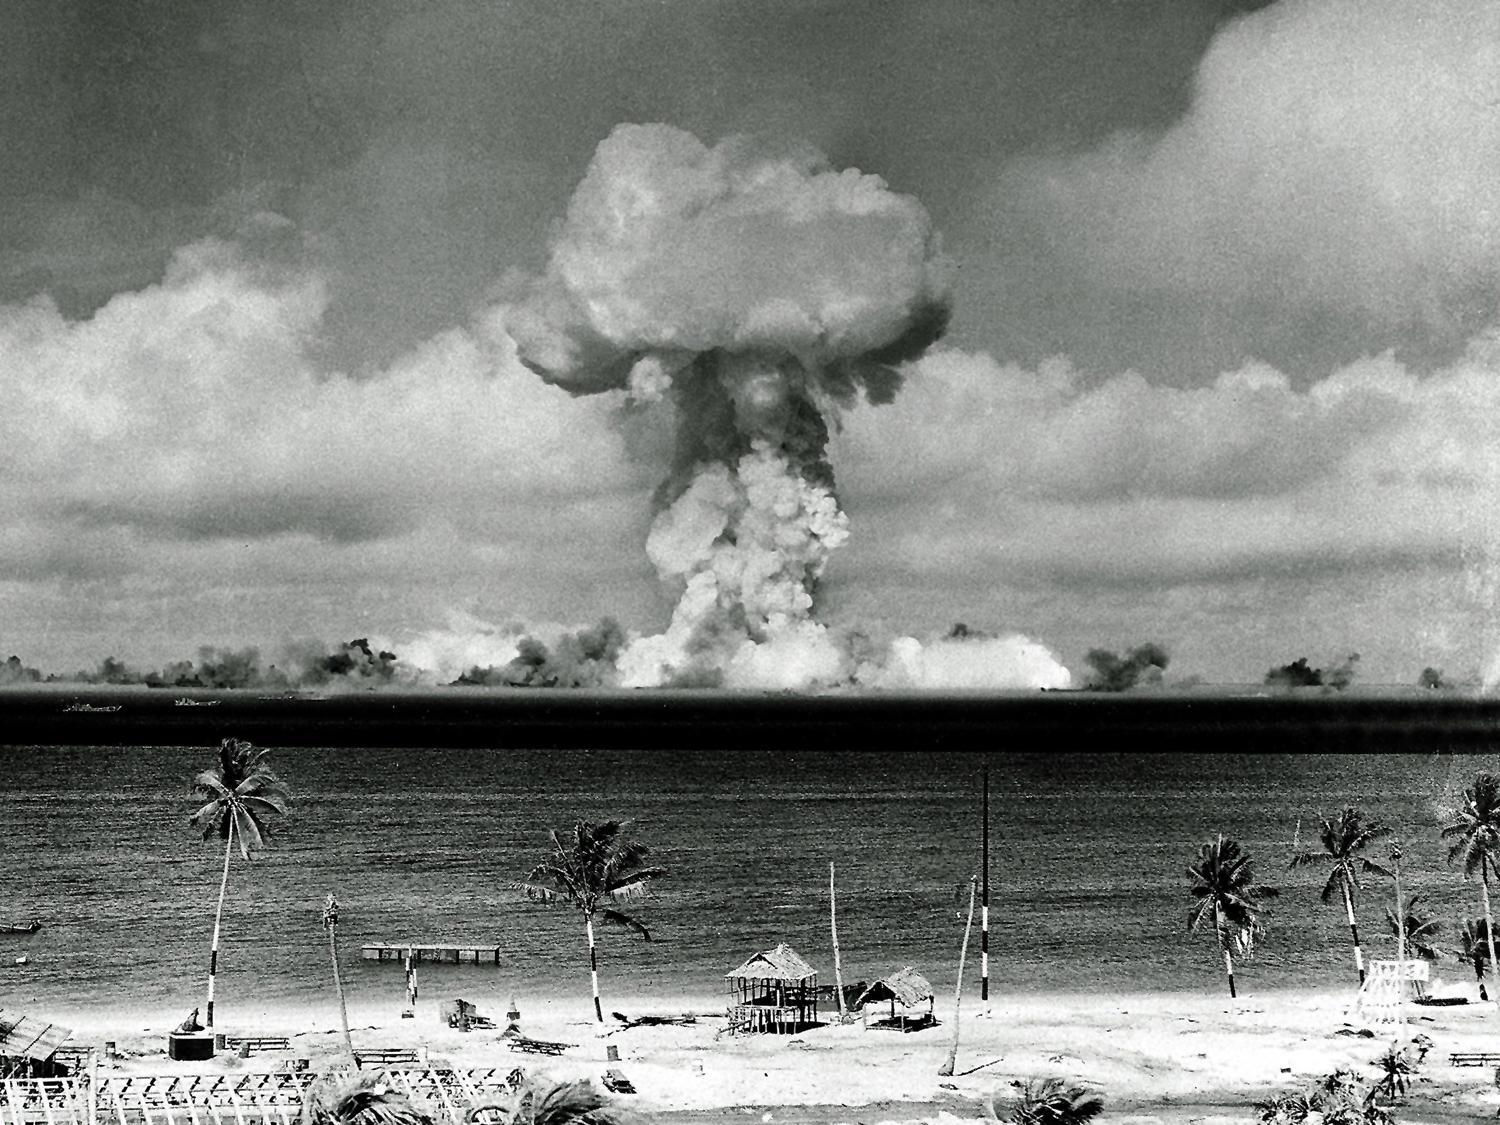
(510, 125, 953, 393)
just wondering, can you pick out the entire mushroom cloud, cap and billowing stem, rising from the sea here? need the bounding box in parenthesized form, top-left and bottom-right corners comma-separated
(510, 125, 951, 687)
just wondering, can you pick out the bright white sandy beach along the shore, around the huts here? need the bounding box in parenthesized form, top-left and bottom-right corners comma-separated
(45, 984, 1500, 1125)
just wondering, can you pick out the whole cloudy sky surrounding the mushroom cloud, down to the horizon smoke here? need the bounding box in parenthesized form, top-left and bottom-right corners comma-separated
(0, 0, 1500, 683)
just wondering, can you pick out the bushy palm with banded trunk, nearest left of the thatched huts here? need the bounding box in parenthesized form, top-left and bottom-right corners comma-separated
(510, 821, 666, 1023)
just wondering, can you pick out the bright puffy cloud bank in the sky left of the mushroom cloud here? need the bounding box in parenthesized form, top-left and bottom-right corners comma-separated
(0, 232, 657, 564)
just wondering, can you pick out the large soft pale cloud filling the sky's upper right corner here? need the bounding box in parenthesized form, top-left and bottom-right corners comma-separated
(998, 0, 1500, 344)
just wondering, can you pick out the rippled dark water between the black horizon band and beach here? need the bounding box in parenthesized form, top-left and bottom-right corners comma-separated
(0, 747, 1500, 1013)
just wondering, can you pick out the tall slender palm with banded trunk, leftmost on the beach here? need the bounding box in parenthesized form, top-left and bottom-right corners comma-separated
(188, 738, 288, 1029)
